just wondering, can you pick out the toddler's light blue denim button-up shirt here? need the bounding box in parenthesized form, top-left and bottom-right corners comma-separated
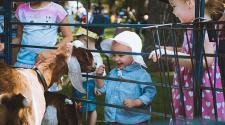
(99, 63, 156, 124)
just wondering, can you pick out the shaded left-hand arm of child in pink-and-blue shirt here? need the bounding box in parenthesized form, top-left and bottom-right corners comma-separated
(12, 24, 23, 44)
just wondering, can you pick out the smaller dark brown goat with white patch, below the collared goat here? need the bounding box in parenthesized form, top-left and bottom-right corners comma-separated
(42, 92, 78, 125)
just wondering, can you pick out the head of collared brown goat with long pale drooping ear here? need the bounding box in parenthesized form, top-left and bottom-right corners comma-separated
(35, 43, 95, 92)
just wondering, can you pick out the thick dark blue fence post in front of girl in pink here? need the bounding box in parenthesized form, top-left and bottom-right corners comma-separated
(193, 0, 205, 119)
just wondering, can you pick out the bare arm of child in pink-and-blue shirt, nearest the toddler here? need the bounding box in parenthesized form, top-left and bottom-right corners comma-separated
(60, 17, 73, 42)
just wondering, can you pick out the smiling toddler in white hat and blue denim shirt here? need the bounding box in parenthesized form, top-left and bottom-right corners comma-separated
(96, 31, 156, 125)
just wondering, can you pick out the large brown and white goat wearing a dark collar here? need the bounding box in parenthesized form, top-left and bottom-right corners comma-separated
(0, 43, 93, 125)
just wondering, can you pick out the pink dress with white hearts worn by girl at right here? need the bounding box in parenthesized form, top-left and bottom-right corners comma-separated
(172, 31, 225, 121)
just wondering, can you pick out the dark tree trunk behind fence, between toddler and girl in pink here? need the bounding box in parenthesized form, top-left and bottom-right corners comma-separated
(124, 0, 183, 70)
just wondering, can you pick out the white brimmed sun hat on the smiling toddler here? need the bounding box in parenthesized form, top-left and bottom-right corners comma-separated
(100, 31, 147, 67)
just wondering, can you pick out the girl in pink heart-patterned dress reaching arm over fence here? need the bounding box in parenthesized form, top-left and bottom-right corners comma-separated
(149, 0, 225, 121)
